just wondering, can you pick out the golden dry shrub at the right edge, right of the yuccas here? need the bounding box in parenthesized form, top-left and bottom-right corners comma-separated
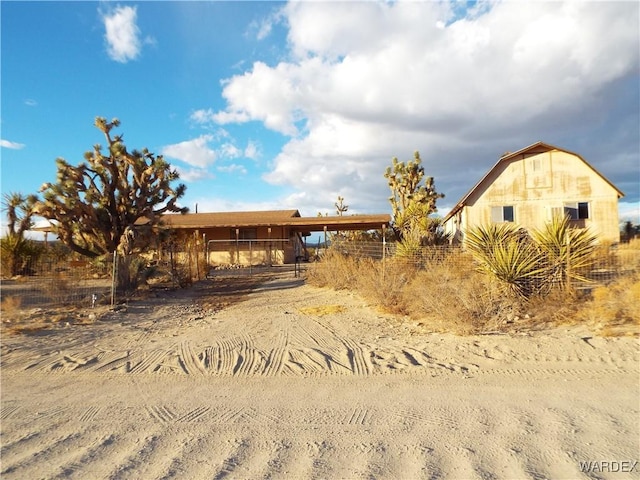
(577, 273, 640, 336)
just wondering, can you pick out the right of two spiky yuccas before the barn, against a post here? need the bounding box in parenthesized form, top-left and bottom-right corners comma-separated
(532, 215, 597, 287)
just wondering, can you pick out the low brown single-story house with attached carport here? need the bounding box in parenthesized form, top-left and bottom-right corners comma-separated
(162, 210, 391, 266)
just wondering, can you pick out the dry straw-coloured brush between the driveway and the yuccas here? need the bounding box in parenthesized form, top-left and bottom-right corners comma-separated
(307, 252, 527, 334)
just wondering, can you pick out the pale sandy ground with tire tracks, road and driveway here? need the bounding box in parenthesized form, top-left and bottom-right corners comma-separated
(0, 273, 640, 480)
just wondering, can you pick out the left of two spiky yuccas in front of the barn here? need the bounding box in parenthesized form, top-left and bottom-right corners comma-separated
(465, 223, 545, 297)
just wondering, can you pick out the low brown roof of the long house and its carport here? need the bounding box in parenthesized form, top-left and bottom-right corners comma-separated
(162, 210, 391, 232)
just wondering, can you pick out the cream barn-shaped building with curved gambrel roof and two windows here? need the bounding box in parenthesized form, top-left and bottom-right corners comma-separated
(443, 142, 624, 243)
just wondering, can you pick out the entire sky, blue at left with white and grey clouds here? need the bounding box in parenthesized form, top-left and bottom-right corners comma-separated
(0, 1, 640, 232)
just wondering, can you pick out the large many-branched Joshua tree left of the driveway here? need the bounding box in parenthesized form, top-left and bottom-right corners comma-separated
(35, 117, 187, 288)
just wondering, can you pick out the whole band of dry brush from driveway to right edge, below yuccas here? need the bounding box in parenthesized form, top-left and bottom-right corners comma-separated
(307, 246, 640, 335)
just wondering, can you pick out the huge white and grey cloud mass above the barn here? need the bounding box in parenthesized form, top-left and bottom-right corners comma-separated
(202, 1, 640, 214)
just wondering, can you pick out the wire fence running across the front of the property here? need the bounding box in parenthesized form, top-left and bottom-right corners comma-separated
(0, 236, 640, 309)
